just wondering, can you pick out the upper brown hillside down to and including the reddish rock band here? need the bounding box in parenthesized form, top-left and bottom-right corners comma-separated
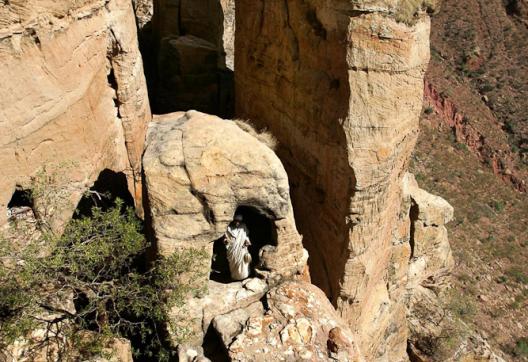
(426, 0, 528, 192)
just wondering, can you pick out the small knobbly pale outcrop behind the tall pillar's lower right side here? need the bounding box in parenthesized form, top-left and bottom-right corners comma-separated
(403, 173, 454, 352)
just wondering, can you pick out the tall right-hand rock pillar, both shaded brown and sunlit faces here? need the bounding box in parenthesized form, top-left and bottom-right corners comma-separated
(235, 0, 429, 361)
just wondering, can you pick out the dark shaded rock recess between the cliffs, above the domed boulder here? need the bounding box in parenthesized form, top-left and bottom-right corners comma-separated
(148, 0, 235, 117)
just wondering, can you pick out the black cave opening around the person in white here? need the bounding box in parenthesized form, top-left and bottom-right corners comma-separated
(210, 206, 277, 283)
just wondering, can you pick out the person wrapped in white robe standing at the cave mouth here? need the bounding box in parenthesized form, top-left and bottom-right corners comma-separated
(224, 215, 251, 280)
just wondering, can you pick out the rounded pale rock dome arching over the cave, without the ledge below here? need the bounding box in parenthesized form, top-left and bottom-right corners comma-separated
(143, 111, 302, 262)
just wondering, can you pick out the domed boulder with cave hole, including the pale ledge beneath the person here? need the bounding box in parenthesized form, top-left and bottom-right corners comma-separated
(143, 111, 307, 346)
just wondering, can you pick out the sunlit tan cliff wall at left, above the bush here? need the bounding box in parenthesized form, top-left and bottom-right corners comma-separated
(0, 0, 150, 224)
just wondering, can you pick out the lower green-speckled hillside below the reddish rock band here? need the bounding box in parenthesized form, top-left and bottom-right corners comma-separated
(411, 113, 528, 360)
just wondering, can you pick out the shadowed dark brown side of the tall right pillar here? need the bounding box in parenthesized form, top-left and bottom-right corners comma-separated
(235, 0, 355, 305)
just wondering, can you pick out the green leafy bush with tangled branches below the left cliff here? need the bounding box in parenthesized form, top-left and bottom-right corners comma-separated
(0, 200, 207, 360)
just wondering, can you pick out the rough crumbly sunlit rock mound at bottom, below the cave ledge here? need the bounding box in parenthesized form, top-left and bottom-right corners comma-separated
(213, 282, 363, 361)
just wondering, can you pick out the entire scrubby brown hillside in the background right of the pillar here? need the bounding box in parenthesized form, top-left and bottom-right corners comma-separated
(413, 0, 528, 360)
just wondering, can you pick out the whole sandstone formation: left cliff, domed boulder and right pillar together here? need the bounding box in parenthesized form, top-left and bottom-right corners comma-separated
(0, 0, 460, 361)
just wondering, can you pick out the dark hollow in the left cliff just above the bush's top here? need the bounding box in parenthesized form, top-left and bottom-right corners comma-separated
(73, 169, 134, 219)
